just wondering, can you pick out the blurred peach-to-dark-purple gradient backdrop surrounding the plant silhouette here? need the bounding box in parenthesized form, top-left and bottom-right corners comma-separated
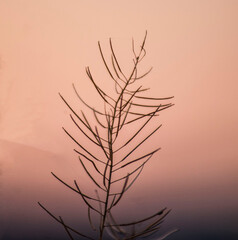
(0, 0, 238, 240)
